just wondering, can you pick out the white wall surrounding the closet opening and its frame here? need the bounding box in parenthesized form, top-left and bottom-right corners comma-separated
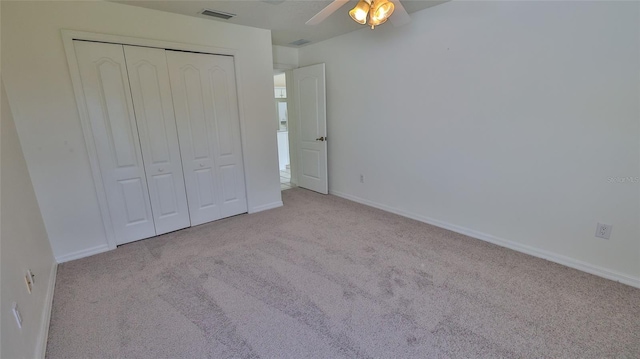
(2, 1, 281, 260)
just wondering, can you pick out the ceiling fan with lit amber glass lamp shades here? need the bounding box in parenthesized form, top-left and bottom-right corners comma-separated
(306, 0, 411, 29)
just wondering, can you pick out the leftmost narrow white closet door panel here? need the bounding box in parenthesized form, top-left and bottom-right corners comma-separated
(74, 41, 156, 244)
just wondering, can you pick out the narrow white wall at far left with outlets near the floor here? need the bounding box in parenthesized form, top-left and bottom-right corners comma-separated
(0, 80, 56, 358)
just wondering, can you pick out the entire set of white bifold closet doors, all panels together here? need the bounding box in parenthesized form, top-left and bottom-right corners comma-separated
(74, 41, 247, 244)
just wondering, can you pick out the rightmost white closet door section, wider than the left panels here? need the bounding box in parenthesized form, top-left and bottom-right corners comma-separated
(166, 51, 247, 225)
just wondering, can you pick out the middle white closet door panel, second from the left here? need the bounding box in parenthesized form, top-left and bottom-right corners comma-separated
(124, 46, 191, 235)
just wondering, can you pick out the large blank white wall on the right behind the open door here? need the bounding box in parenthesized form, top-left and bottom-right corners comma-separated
(299, 1, 640, 286)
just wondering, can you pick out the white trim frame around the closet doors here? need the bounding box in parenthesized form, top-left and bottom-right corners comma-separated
(61, 29, 252, 249)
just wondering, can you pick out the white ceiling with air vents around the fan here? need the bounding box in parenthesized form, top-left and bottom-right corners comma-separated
(110, 0, 446, 47)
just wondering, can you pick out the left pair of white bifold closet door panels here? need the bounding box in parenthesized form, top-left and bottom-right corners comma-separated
(74, 41, 190, 244)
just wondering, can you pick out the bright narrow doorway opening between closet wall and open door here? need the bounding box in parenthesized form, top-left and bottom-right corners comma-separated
(273, 72, 294, 191)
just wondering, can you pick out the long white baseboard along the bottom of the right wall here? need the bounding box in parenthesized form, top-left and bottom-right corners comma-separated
(329, 190, 640, 288)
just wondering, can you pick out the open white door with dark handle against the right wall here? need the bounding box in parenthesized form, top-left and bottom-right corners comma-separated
(293, 64, 329, 194)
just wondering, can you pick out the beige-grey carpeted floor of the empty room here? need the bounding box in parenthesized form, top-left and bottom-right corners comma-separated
(47, 189, 640, 359)
